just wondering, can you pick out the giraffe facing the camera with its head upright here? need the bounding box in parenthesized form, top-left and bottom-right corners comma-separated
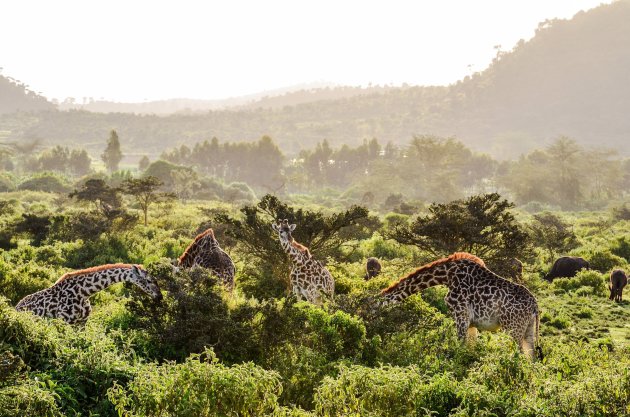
(271, 219, 335, 304)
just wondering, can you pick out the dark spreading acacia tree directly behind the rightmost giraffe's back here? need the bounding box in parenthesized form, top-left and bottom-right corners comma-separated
(387, 193, 531, 274)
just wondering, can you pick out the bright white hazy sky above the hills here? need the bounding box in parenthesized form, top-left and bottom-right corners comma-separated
(0, 0, 610, 101)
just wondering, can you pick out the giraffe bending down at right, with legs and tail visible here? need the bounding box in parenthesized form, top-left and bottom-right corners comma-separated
(381, 252, 540, 359)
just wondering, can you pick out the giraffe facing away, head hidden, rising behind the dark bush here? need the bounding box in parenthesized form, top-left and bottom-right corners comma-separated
(177, 229, 236, 291)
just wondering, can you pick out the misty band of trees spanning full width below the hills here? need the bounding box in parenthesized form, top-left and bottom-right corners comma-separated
(0, 131, 630, 212)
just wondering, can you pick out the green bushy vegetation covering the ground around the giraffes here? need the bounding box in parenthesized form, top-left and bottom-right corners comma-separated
(0, 184, 630, 417)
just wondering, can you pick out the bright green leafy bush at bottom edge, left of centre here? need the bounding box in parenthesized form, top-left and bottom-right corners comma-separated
(109, 350, 282, 417)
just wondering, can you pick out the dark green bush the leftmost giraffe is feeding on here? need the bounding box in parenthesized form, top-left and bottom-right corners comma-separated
(129, 259, 257, 362)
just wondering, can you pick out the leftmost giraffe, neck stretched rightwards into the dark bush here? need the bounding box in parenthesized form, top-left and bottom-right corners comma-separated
(15, 264, 162, 324)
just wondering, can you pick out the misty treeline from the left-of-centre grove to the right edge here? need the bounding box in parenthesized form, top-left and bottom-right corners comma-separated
(162, 135, 630, 209)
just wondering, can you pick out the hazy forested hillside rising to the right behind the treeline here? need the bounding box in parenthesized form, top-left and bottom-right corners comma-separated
(0, 0, 630, 157)
